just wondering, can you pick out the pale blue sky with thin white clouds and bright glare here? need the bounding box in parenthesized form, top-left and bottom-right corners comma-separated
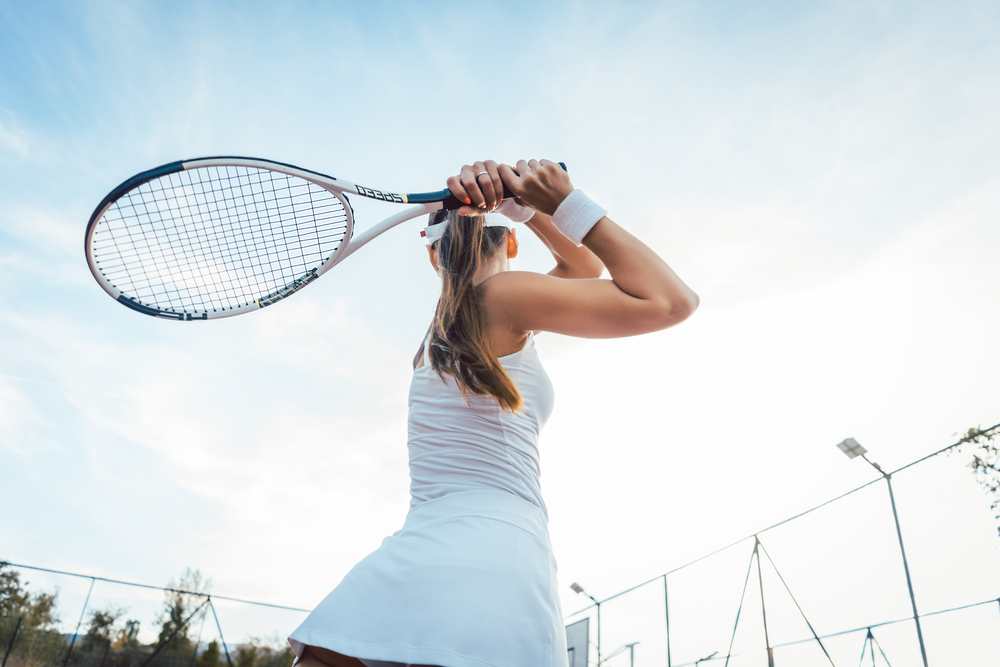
(0, 0, 1000, 665)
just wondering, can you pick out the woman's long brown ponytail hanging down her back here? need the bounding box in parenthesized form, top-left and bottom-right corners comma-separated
(427, 210, 524, 412)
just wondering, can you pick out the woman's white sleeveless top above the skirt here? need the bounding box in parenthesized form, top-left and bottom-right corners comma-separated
(407, 334, 555, 517)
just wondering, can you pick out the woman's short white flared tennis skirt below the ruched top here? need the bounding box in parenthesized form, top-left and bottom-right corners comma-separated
(288, 489, 567, 667)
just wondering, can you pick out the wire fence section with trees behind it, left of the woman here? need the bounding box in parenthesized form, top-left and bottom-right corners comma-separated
(0, 563, 308, 667)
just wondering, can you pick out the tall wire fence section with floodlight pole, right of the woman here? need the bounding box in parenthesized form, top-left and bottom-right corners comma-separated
(567, 425, 1000, 667)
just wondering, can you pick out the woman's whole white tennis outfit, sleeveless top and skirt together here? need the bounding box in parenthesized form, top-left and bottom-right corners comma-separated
(288, 336, 567, 667)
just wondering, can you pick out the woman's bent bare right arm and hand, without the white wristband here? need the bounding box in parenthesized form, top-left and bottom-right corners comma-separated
(482, 160, 699, 338)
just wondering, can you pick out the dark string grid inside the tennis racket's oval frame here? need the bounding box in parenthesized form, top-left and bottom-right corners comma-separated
(93, 166, 348, 313)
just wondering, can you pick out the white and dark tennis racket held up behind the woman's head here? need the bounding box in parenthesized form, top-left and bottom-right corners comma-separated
(84, 157, 565, 321)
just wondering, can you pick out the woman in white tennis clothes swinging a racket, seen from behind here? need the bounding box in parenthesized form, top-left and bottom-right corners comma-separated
(289, 160, 698, 667)
